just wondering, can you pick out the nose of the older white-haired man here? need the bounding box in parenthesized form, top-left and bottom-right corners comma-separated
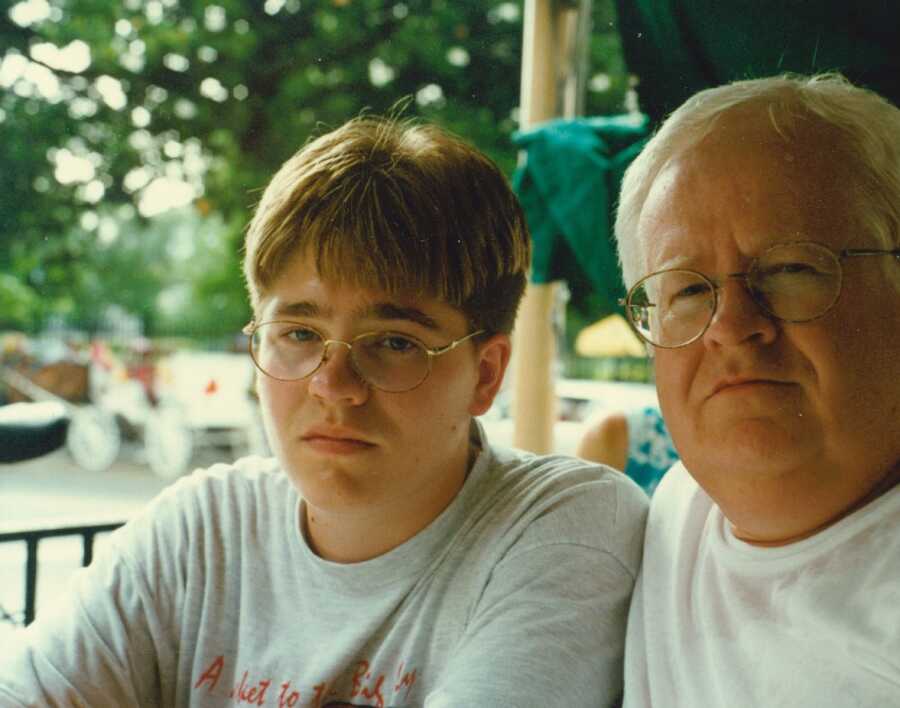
(703, 274, 778, 346)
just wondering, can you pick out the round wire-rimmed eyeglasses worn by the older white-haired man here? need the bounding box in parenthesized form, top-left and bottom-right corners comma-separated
(620, 241, 900, 349)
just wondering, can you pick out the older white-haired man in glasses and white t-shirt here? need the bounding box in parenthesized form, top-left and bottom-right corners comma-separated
(616, 75, 900, 708)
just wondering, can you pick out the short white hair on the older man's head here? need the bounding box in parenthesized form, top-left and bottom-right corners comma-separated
(615, 73, 900, 290)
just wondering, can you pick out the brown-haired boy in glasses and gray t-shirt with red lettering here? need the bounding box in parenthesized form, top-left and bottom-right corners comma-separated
(0, 113, 646, 708)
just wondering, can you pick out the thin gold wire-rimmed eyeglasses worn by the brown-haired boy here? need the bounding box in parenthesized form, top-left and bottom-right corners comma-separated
(242, 320, 485, 393)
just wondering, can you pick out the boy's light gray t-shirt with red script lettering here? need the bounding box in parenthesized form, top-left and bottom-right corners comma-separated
(0, 426, 647, 708)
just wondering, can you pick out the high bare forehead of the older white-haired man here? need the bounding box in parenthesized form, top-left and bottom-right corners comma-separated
(642, 134, 852, 272)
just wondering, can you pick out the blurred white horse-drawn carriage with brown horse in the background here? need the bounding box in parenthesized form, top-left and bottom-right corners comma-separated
(0, 334, 265, 478)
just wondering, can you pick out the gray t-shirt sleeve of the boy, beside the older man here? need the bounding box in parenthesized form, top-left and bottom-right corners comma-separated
(425, 472, 647, 708)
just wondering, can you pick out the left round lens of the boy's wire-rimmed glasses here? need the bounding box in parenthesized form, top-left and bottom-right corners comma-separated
(250, 322, 325, 381)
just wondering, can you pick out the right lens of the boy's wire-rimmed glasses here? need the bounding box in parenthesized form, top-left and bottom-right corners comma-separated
(351, 332, 431, 393)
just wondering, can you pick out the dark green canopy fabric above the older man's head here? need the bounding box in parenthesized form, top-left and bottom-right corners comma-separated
(616, 0, 900, 125)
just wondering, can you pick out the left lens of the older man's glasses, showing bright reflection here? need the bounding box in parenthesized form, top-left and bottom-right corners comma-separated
(626, 270, 716, 348)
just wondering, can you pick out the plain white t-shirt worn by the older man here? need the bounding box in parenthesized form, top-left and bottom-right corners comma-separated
(625, 463, 900, 708)
